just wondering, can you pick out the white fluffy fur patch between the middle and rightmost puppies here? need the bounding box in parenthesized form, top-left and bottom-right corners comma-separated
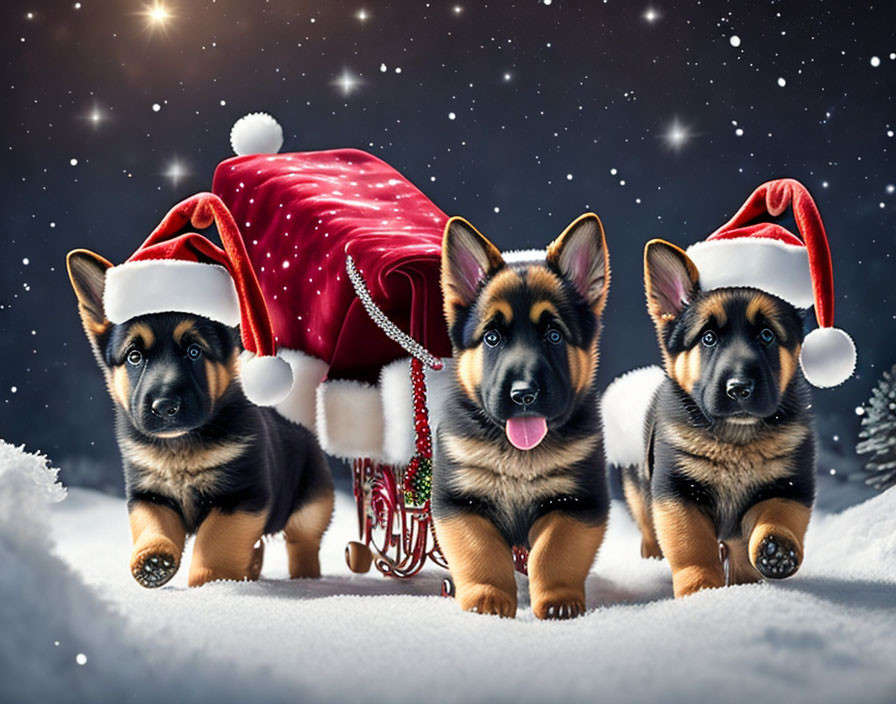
(600, 366, 666, 467)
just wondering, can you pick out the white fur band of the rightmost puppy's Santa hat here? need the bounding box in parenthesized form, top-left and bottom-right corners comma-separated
(687, 237, 815, 308)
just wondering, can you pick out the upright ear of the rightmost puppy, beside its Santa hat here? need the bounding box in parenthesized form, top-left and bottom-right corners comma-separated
(644, 240, 700, 325)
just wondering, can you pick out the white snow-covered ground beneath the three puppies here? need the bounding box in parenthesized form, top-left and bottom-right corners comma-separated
(0, 443, 896, 704)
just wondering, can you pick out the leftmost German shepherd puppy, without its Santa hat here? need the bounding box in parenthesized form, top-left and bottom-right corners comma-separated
(67, 250, 333, 587)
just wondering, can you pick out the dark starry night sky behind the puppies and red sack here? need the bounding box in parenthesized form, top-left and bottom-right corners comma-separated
(0, 0, 896, 484)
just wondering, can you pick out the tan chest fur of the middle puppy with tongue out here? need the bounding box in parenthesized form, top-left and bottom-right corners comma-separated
(444, 435, 597, 516)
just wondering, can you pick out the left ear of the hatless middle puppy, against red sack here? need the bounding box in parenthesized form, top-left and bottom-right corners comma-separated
(442, 217, 504, 328)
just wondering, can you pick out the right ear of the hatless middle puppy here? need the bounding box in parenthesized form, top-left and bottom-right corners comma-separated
(547, 213, 610, 315)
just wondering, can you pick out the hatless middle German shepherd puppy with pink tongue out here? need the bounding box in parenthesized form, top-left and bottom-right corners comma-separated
(432, 213, 610, 619)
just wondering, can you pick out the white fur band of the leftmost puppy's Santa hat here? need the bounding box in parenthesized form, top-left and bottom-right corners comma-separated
(103, 259, 240, 327)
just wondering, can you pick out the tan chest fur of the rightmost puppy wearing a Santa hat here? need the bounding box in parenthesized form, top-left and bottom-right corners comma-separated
(662, 425, 809, 511)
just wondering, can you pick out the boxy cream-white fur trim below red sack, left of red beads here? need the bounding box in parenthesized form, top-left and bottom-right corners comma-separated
(317, 379, 383, 460)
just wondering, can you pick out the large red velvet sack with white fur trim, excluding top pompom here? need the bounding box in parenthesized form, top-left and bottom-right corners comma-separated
(212, 138, 451, 457)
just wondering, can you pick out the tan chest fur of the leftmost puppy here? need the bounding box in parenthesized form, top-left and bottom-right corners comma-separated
(122, 438, 251, 524)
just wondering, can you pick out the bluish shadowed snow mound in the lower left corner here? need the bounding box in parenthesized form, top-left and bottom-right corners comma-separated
(0, 440, 276, 703)
